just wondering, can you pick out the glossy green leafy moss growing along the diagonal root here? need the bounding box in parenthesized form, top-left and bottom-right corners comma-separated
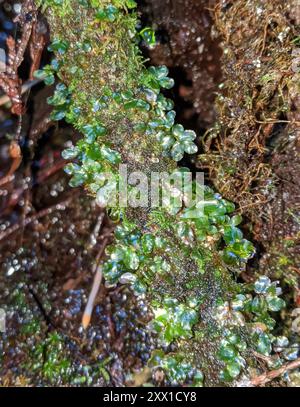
(38, 0, 290, 385)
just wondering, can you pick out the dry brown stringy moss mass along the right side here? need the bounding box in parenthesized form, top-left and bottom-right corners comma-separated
(197, 0, 300, 382)
